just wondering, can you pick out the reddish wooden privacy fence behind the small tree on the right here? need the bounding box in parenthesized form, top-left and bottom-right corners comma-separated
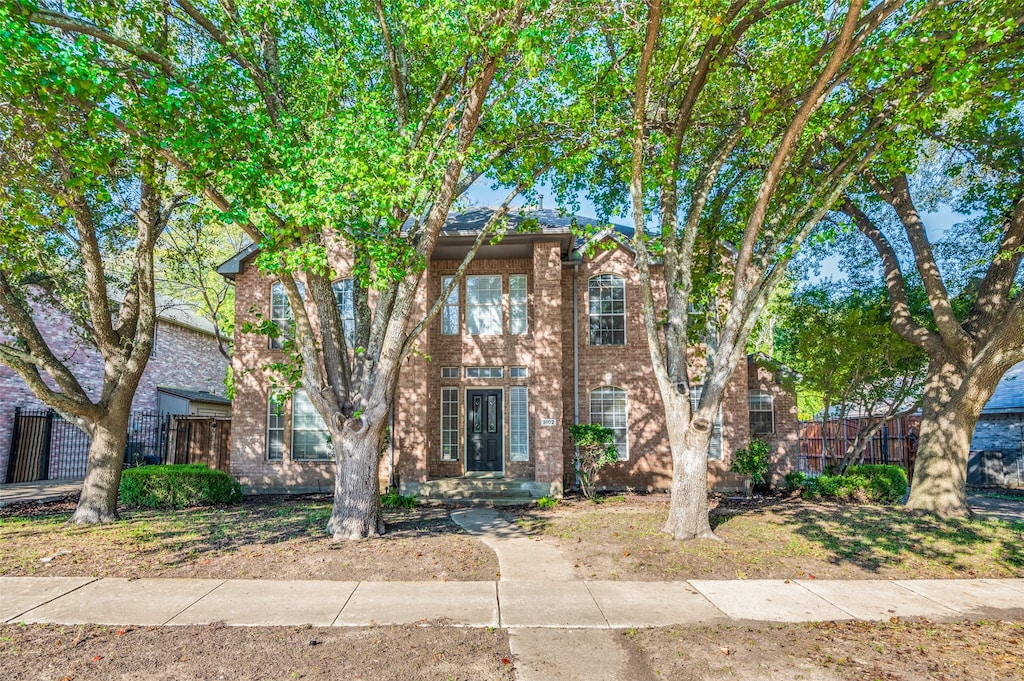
(798, 415, 921, 478)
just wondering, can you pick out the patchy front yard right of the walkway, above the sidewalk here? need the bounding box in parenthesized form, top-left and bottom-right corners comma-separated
(509, 495, 1024, 581)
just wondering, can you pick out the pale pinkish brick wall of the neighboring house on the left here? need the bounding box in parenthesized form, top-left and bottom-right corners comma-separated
(0, 299, 227, 479)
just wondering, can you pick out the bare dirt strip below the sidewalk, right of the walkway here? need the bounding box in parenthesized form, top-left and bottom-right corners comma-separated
(623, 620, 1024, 681)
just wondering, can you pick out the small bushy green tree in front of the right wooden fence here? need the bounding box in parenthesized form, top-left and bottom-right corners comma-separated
(778, 287, 926, 473)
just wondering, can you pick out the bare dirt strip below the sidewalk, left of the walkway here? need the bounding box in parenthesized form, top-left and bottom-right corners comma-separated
(0, 625, 513, 681)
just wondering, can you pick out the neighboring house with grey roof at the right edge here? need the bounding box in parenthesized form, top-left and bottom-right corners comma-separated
(968, 361, 1024, 487)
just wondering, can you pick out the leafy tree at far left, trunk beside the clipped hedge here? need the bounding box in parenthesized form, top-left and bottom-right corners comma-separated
(0, 30, 178, 523)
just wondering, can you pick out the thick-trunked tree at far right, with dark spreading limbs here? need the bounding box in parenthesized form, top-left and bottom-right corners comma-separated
(843, 103, 1024, 516)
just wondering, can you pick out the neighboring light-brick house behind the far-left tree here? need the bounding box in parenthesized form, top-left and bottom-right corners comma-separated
(0, 296, 230, 482)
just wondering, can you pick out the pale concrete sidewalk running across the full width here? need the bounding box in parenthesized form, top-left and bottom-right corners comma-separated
(0, 577, 1024, 630)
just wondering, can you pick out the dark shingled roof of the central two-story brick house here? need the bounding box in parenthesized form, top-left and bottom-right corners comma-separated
(217, 207, 633, 282)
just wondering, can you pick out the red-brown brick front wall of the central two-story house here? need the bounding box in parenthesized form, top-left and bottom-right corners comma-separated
(231, 227, 797, 495)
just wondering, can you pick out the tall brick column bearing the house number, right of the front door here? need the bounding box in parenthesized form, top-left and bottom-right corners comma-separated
(529, 242, 571, 495)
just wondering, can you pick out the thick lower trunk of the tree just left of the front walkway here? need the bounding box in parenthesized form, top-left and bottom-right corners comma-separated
(327, 410, 387, 540)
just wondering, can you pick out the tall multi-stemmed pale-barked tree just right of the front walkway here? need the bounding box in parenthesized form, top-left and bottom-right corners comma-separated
(581, 0, 1019, 540)
